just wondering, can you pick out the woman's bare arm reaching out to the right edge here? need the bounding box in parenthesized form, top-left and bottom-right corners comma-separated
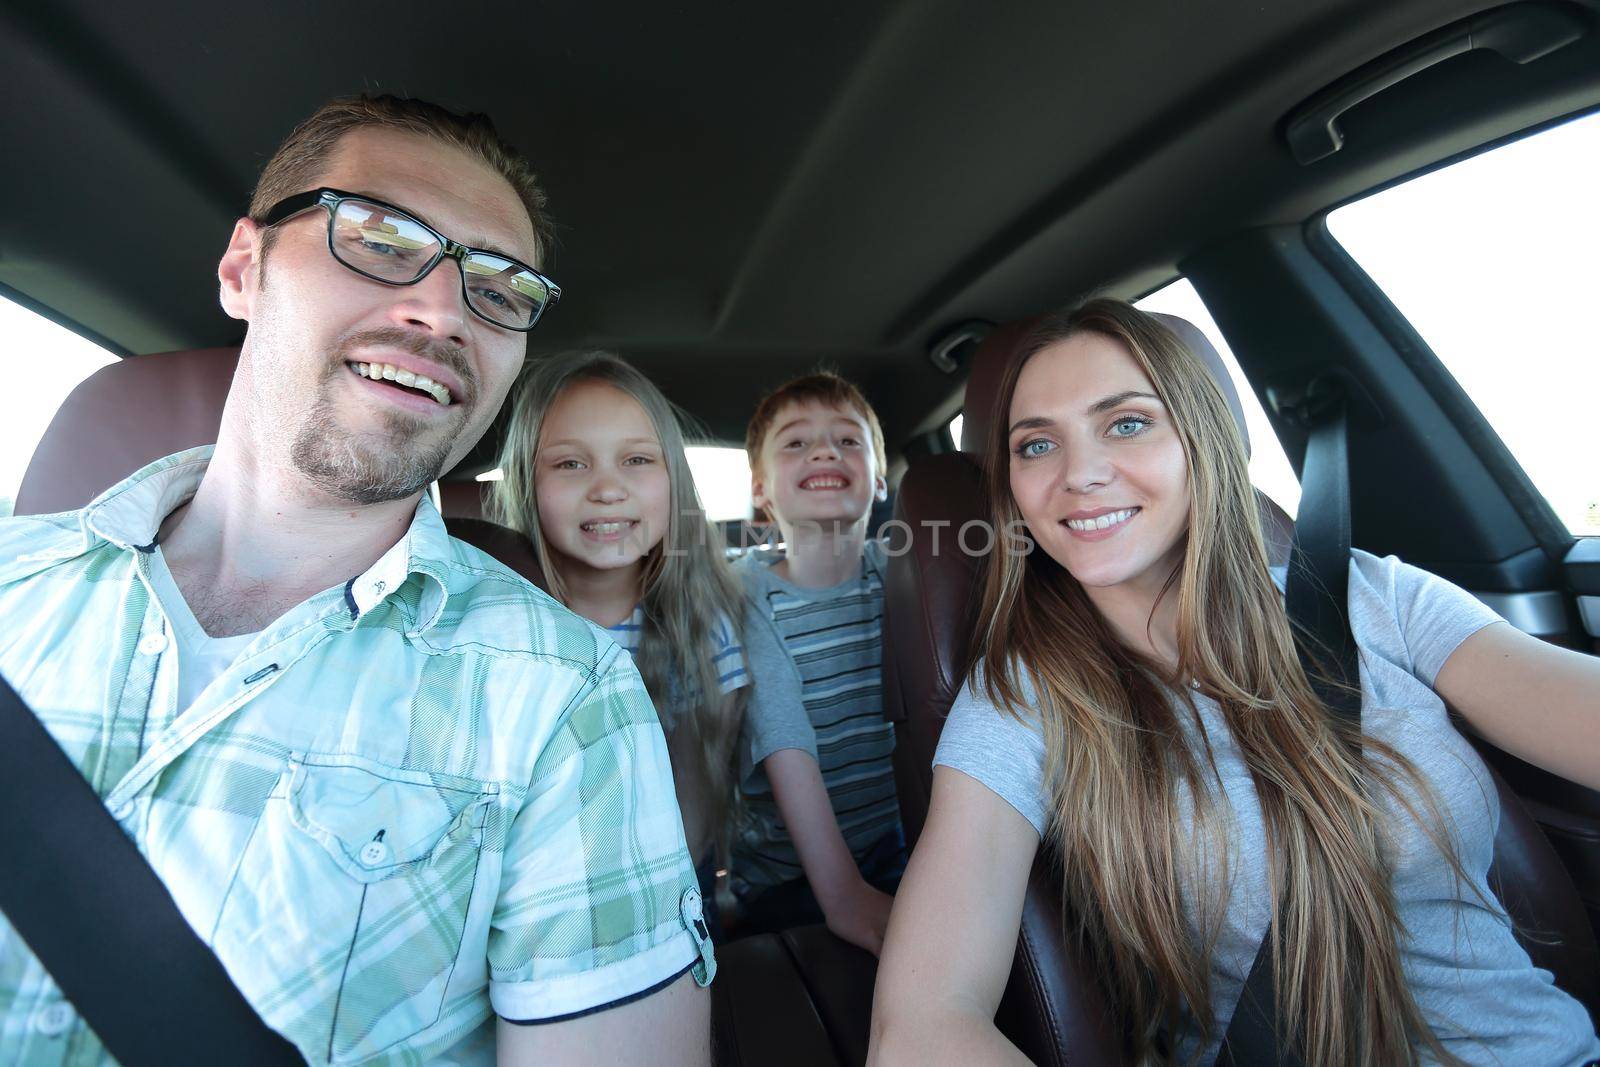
(1434, 622, 1600, 789)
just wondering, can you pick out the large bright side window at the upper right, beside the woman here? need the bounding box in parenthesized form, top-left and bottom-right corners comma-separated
(1328, 115, 1600, 536)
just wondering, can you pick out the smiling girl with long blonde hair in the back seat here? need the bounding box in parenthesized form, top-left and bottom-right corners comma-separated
(490, 352, 749, 910)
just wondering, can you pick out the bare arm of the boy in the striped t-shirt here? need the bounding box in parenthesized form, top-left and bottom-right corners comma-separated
(763, 749, 894, 955)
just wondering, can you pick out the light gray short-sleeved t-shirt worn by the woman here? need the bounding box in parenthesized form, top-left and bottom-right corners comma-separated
(934, 550, 1600, 1067)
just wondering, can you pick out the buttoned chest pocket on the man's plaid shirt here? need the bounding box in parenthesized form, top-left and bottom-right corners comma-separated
(214, 753, 498, 1064)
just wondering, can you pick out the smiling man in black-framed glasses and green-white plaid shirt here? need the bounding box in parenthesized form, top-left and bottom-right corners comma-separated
(0, 98, 715, 1064)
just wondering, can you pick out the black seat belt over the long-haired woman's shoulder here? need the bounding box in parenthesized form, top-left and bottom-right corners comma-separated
(1216, 374, 1362, 1067)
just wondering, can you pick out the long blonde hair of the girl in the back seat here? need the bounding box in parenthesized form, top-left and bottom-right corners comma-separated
(488, 352, 746, 862)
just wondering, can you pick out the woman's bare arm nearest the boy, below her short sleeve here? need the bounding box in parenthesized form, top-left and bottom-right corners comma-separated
(867, 766, 1038, 1064)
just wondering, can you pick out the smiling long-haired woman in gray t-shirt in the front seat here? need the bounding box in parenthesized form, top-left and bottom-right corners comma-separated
(874, 301, 1600, 1065)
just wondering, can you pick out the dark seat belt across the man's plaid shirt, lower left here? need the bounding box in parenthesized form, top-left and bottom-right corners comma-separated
(0, 678, 306, 1067)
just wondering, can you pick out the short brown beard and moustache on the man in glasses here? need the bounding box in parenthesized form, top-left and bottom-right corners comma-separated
(290, 330, 477, 504)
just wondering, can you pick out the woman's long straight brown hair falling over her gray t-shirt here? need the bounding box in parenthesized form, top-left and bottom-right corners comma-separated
(974, 299, 1464, 1065)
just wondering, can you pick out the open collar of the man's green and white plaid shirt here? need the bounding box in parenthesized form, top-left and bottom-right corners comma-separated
(80, 445, 456, 637)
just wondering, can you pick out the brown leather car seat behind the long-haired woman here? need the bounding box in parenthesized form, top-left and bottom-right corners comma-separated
(885, 315, 1600, 1064)
